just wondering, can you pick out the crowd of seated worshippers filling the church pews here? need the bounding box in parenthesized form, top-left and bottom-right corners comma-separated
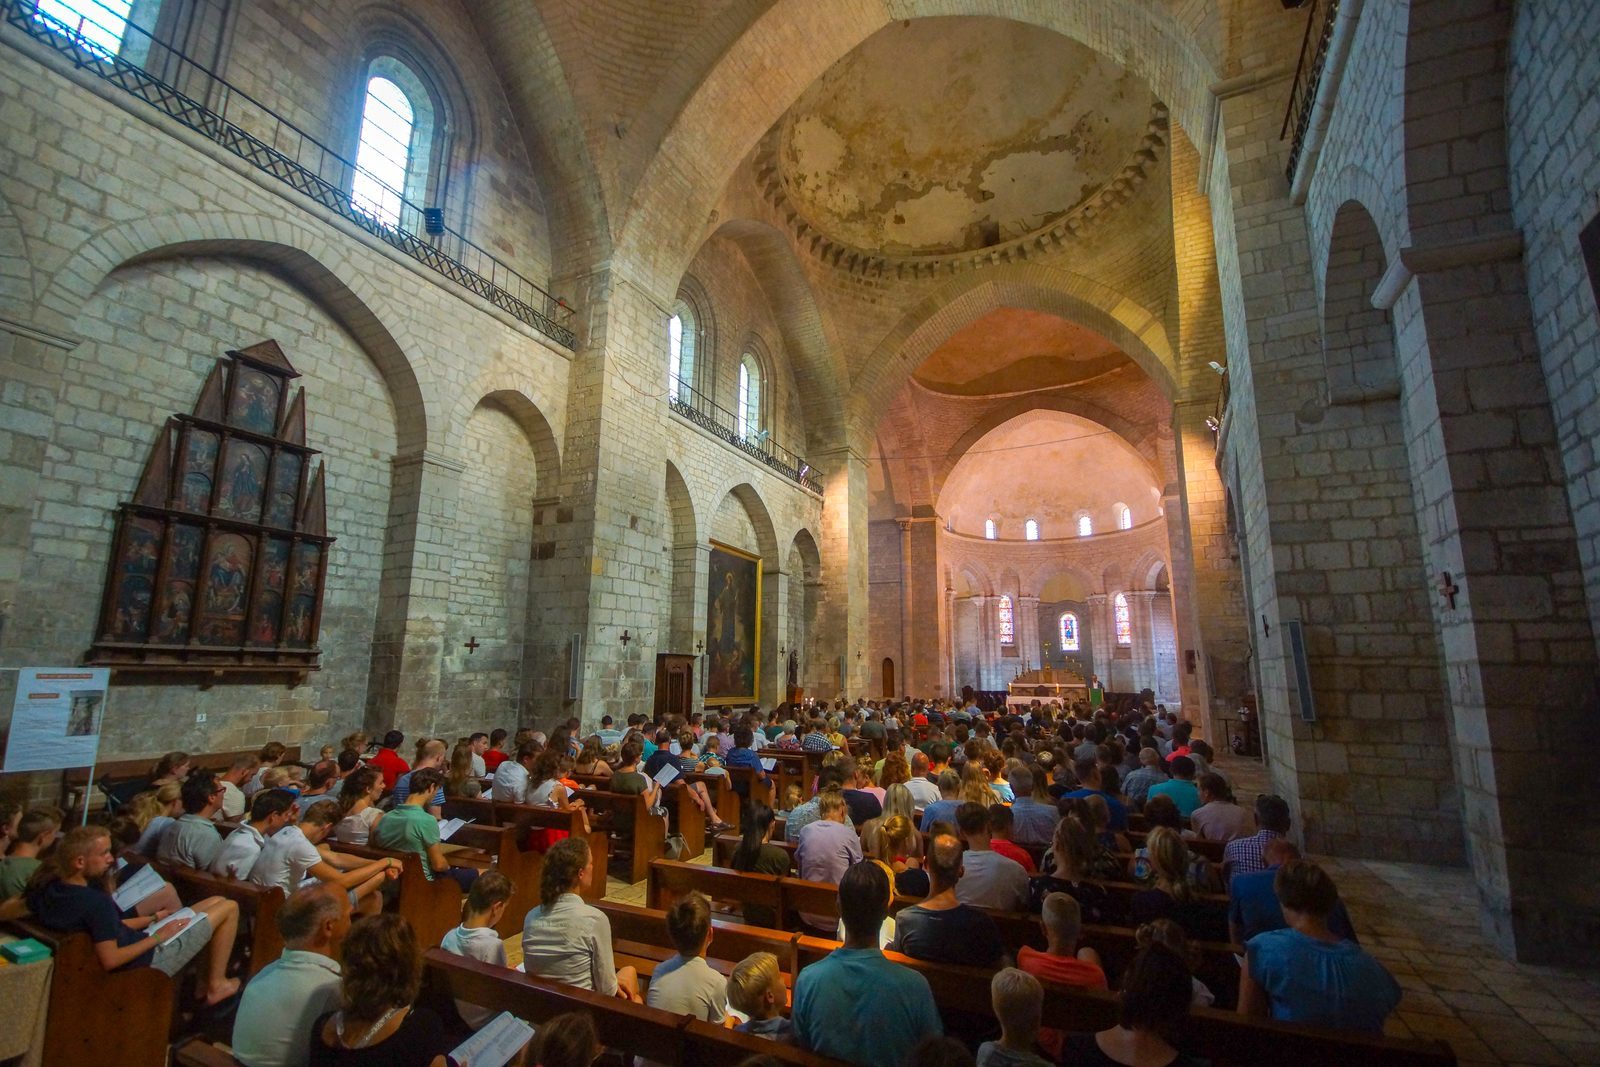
(0, 701, 1400, 1067)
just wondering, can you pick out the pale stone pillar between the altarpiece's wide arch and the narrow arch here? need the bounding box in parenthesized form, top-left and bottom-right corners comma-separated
(366, 451, 464, 736)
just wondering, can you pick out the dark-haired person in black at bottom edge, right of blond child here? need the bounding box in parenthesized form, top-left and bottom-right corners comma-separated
(1061, 945, 1203, 1067)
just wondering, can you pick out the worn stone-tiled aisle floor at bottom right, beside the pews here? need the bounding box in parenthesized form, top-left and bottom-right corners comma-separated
(606, 757, 1600, 1067)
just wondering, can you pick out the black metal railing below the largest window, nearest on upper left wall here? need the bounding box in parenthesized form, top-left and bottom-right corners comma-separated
(0, 0, 576, 349)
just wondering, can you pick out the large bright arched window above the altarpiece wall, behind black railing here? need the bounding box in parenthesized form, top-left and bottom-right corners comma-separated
(350, 56, 435, 230)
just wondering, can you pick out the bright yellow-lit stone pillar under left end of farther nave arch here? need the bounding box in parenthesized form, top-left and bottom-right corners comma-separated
(808, 446, 870, 697)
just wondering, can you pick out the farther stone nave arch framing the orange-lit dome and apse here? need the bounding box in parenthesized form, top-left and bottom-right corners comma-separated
(851, 264, 1176, 426)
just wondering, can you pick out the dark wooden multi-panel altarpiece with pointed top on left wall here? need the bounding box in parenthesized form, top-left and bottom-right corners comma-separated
(90, 341, 333, 680)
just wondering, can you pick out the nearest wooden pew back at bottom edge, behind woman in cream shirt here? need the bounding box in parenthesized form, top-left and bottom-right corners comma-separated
(422, 949, 838, 1067)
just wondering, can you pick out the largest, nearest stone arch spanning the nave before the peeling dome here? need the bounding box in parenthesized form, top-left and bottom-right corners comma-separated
(618, 0, 1218, 300)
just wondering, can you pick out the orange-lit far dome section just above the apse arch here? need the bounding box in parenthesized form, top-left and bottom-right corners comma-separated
(914, 307, 1133, 397)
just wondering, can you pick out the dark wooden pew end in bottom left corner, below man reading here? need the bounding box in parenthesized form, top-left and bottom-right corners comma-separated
(8, 920, 181, 1067)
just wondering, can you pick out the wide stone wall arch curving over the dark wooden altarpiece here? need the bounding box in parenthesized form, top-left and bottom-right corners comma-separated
(38, 213, 443, 456)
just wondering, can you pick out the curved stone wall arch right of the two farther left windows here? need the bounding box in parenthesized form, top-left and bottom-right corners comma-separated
(715, 219, 846, 440)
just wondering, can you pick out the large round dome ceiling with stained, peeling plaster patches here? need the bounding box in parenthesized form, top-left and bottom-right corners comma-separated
(774, 18, 1165, 256)
